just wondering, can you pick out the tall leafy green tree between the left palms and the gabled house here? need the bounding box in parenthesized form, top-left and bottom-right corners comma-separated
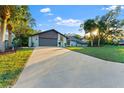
(8, 6, 35, 46)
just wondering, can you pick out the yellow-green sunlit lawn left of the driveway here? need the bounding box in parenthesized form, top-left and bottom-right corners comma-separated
(0, 49, 32, 87)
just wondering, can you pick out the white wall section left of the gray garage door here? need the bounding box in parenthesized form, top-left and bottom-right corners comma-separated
(29, 35, 39, 47)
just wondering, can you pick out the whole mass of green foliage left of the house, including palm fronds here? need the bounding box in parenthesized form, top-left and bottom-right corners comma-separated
(0, 5, 37, 46)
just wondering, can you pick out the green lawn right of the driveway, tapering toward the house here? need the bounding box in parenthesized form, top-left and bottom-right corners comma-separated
(67, 46, 124, 63)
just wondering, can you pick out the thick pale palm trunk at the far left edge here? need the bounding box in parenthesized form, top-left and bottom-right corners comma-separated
(0, 19, 7, 52)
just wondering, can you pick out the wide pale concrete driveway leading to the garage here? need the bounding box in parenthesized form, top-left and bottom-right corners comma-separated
(13, 47, 124, 88)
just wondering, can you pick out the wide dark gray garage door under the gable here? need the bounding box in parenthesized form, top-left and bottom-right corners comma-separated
(39, 38, 57, 46)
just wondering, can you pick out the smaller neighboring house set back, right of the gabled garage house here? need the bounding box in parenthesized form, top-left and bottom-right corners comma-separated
(68, 36, 87, 46)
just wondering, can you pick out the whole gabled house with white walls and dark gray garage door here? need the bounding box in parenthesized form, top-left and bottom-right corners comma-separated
(29, 29, 67, 47)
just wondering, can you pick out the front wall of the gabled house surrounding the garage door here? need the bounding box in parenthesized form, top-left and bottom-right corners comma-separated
(28, 31, 67, 47)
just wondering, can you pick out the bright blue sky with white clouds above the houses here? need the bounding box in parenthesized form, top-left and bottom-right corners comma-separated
(29, 5, 124, 35)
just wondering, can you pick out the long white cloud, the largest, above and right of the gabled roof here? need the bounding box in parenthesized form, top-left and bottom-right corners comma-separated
(54, 17, 82, 26)
